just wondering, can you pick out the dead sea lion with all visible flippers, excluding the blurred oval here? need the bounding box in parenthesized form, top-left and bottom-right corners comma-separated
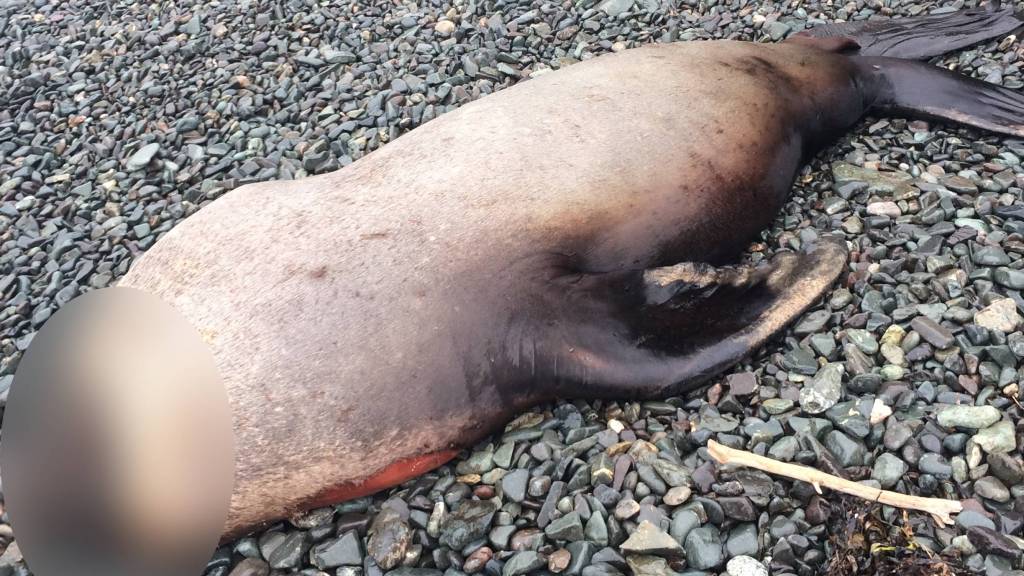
(105, 3, 1024, 535)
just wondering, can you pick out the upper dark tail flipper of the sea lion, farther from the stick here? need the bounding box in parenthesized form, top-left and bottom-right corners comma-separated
(786, 2, 1024, 59)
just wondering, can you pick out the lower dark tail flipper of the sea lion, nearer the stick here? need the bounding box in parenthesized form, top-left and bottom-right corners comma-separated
(853, 56, 1024, 137)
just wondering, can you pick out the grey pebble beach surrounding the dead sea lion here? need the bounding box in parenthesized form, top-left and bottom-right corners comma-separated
(0, 0, 1024, 576)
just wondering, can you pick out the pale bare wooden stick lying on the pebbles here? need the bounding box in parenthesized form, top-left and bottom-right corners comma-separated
(708, 440, 964, 524)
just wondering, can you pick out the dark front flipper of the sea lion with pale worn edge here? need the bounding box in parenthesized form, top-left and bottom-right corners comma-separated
(557, 238, 847, 398)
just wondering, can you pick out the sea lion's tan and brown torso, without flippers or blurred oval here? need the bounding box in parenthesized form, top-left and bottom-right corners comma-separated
(121, 42, 863, 526)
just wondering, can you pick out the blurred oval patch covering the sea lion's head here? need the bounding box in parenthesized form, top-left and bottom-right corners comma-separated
(0, 288, 234, 576)
